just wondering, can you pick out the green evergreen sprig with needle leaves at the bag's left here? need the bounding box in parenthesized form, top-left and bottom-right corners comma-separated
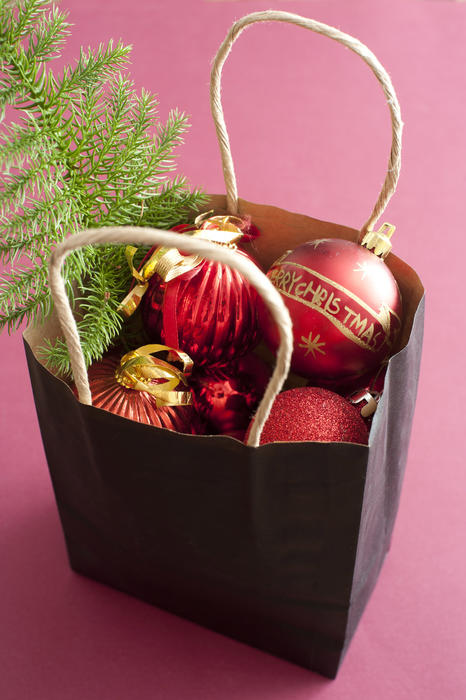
(0, 0, 205, 374)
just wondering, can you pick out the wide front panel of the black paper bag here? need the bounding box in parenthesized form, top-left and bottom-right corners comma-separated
(26, 344, 369, 677)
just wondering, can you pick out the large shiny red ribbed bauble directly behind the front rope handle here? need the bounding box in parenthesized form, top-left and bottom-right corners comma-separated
(141, 250, 258, 365)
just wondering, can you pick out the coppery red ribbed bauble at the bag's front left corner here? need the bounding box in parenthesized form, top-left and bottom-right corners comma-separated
(74, 353, 199, 434)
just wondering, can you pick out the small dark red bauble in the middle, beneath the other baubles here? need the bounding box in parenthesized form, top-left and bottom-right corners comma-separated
(190, 354, 271, 440)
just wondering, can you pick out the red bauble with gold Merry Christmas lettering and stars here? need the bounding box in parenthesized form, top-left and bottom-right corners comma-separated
(261, 238, 401, 387)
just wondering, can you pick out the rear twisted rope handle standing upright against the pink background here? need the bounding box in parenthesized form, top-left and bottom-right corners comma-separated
(210, 10, 403, 233)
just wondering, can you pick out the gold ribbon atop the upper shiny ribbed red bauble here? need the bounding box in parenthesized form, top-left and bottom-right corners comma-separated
(118, 212, 243, 318)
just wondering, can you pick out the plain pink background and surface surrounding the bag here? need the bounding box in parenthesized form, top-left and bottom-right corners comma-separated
(0, 0, 466, 700)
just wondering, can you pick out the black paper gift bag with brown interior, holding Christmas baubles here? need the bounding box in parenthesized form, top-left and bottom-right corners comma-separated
(24, 13, 423, 677)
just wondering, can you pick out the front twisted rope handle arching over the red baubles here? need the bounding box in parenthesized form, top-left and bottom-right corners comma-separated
(49, 226, 293, 447)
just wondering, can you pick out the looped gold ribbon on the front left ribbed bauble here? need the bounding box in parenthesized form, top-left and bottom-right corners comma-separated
(115, 344, 193, 408)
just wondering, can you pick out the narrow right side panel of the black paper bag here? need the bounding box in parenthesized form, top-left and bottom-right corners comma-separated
(345, 298, 425, 651)
